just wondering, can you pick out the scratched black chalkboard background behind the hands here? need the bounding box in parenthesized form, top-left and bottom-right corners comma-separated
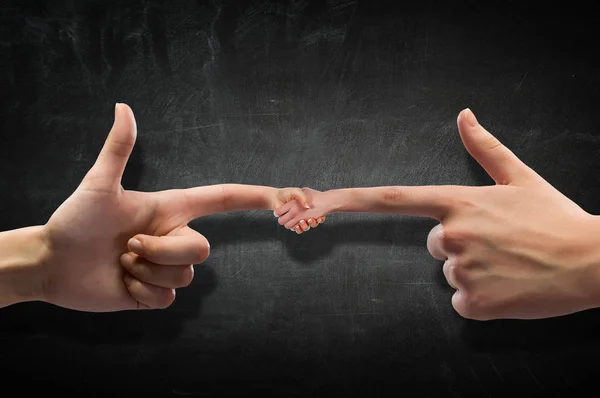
(0, 0, 600, 397)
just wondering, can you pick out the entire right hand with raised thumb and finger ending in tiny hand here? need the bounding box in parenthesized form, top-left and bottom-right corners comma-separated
(275, 109, 600, 320)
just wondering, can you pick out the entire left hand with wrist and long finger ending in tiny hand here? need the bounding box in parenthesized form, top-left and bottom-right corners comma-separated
(0, 104, 324, 312)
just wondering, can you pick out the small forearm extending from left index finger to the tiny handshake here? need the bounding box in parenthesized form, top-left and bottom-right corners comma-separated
(184, 184, 277, 216)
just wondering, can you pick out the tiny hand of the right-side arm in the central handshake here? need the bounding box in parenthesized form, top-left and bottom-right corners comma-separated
(274, 188, 329, 234)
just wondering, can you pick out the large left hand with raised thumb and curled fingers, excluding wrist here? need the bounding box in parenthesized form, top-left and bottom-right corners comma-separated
(40, 104, 209, 312)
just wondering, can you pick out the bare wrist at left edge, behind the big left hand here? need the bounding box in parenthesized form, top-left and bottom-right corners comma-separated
(0, 226, 48, 307)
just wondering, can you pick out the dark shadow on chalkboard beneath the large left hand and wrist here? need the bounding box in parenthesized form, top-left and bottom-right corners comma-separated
(0, 264, 216, 344)
